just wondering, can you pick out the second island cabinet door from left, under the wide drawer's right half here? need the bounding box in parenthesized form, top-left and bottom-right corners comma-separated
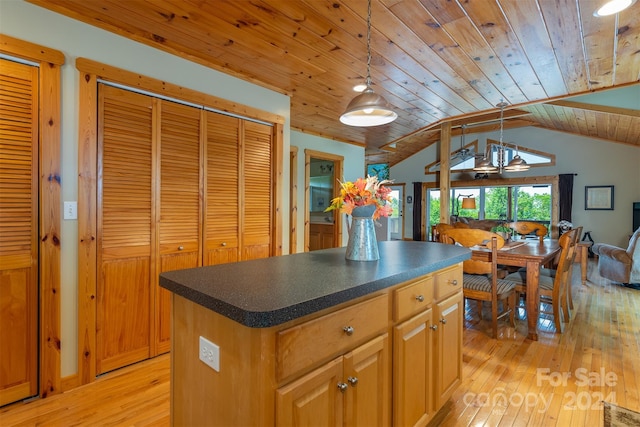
(343, 334, 391, 427)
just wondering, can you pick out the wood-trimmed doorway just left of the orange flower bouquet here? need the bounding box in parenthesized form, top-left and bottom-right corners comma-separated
(304, 150, 344, 252)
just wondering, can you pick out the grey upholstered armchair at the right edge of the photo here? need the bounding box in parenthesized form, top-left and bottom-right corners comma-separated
(592, 228, 640, 283)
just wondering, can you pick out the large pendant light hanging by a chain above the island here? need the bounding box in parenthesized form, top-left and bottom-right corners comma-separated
(340, 0, 398, 127)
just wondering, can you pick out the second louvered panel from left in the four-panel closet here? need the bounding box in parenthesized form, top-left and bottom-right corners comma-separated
(154, 101, 203, 353)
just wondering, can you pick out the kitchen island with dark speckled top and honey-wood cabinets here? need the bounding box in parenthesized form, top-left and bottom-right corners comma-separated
(160, 241, 471, 426)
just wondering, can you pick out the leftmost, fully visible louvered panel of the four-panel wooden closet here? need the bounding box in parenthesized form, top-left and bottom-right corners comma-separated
(96, 85, 155, 374)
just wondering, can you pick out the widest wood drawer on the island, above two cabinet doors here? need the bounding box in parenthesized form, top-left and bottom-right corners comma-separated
(276, 294, 389, 380)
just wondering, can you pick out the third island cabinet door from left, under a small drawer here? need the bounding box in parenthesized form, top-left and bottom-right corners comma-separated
(393, 309, 435, 426)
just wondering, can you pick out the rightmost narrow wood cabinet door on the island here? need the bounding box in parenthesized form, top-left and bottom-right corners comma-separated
(434, 292, 464, 408)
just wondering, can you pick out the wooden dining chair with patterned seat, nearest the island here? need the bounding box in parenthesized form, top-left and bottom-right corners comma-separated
(440, 228, 516, 338)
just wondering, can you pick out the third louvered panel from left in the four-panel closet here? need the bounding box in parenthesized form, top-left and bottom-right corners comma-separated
(204, 112, 240, 265)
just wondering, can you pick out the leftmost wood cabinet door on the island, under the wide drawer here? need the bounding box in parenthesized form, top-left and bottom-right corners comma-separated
(276, 357, 343, 427)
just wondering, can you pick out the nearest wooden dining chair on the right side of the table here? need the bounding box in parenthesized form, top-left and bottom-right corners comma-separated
(505, 229, 578, 333)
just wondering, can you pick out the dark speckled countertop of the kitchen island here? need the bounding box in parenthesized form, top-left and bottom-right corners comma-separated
(160, 241, 471, 328)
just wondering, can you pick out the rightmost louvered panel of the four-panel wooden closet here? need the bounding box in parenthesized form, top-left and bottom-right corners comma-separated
(241, 121, 273, 260)
